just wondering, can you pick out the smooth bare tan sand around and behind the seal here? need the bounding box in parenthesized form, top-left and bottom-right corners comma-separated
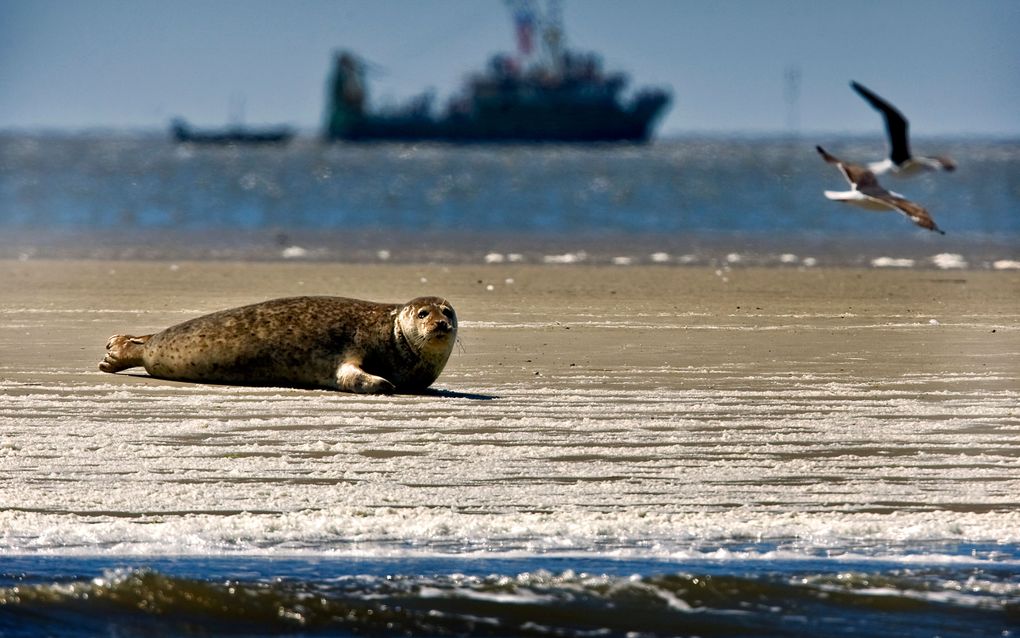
(0, 260, 1020, 392)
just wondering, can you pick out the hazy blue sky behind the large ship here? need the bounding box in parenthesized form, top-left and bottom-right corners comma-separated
(0, 0, 1020, 137)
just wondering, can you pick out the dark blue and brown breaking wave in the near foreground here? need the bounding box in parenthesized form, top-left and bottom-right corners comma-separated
(0, 556, 1017, 637)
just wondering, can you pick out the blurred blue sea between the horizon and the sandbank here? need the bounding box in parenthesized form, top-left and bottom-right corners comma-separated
(0, 133, 1020, 268)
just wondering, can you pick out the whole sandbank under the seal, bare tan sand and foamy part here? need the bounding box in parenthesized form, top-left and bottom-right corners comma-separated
(0, 260, 1020, 555)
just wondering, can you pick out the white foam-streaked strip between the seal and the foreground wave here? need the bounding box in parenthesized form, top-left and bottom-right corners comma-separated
(0, 353, 1020, 560)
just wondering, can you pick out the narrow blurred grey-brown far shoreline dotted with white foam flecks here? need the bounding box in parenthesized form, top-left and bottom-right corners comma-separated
(0, 228, 1020, 271)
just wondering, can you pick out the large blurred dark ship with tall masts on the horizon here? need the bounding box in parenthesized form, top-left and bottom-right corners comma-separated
(323, 0, 671, 143)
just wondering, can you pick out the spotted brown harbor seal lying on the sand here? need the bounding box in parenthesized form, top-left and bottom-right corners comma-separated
(99, 297, 457, 394)
